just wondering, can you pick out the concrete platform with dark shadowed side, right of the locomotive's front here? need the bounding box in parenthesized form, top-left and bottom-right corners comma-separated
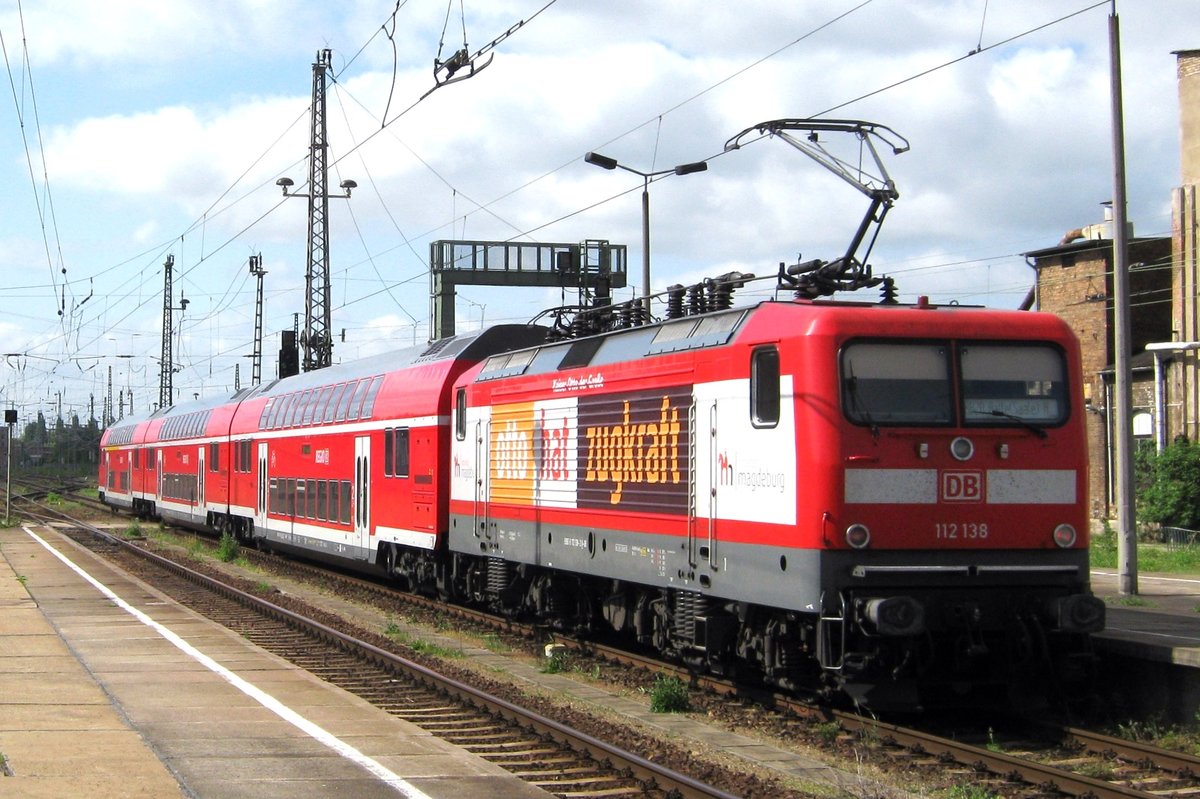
(1092, 571, 1200, 723)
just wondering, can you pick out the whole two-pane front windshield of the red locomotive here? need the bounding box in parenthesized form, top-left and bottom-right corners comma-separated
(841, 342, 1068, 428)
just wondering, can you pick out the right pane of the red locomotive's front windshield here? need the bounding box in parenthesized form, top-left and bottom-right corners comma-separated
(959, 343, 1068, 425)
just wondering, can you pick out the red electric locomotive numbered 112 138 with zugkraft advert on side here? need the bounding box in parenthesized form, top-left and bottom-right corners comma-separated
(448, 292, 1104, 707)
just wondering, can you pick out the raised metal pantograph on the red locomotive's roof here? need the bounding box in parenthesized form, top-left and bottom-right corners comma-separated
(725, 119, 910, 301)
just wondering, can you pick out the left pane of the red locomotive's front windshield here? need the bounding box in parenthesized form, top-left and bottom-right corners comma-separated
(841, 342, 954, 426)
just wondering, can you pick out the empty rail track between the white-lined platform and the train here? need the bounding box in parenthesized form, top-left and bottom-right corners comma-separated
(14, 500, 739, 799)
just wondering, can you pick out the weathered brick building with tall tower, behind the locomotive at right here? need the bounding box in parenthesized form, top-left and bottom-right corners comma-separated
(1026, 50, 1200, 519)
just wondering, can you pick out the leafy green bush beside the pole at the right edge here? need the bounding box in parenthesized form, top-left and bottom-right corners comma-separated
(1136, 441, 1200, 530)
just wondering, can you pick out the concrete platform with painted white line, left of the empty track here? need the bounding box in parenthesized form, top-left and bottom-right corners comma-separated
(0, 527, 548, 799)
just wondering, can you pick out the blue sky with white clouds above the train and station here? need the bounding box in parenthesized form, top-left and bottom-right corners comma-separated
(0, 0, 1200, 421)
